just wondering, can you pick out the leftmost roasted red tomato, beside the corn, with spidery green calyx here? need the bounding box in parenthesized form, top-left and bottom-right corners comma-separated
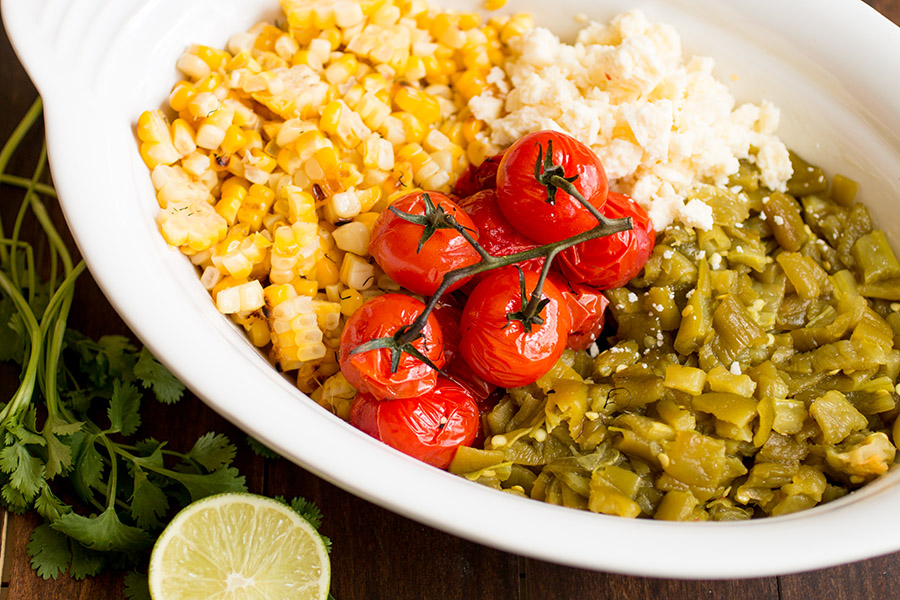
(340, 294, 445, 398)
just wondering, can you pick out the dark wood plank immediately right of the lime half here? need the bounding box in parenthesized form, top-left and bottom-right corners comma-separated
(266, 460, 519, 600)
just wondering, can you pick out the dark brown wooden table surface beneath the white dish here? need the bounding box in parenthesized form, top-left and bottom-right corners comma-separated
(0, 0, 900, 600)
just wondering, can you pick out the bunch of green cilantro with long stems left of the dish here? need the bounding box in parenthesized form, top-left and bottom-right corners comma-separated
(0, 99, 318, 598)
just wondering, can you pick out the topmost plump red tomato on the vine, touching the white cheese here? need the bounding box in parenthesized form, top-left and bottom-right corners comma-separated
(497, 131, 609, 244)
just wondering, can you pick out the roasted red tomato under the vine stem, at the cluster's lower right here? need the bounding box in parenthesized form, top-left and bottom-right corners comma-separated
(459, 268, 570, 387)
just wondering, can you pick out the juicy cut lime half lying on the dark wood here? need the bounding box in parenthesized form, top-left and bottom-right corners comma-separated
(149, 493, 331, 600)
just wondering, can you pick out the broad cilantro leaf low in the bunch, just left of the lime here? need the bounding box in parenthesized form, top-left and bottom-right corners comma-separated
(51, 507, 154, 552)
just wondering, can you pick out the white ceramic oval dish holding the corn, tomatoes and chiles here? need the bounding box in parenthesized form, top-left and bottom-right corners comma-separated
(2, 0, 900, 578)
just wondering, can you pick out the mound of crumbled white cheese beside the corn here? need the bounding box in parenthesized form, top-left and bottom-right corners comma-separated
(469, 10, 791, 230)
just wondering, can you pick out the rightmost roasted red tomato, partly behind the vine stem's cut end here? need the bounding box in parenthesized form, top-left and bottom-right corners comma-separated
(559, 192, 656, 290)
